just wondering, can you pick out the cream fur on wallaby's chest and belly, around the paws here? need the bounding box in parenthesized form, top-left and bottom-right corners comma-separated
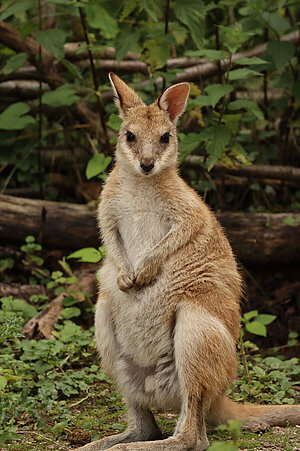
(100, 190, 172, 367)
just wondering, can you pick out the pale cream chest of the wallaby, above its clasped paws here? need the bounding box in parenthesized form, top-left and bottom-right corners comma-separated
(114, 184, 170, 268)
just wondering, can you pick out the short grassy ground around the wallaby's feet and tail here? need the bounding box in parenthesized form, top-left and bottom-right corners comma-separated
(0, 374, 300, 451)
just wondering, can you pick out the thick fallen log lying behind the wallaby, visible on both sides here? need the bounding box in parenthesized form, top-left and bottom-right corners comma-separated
(0, 195, 300, 264)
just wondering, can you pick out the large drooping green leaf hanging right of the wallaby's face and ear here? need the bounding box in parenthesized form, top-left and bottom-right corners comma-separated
(201, 125, 230, 171)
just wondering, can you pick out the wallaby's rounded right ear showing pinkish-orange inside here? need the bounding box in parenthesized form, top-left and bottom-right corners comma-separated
(158, 83, 190, 122)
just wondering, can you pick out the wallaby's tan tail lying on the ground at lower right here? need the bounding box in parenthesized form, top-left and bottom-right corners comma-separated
(208, 396, 300, 430)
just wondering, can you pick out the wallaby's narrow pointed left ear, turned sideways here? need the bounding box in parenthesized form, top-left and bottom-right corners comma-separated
(108, 72, 144, 117)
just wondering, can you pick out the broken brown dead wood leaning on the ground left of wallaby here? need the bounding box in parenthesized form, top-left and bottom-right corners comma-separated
(22, 274, 97, 339)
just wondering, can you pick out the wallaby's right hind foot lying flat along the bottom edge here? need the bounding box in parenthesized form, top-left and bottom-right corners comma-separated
(111, 436, 209, 451)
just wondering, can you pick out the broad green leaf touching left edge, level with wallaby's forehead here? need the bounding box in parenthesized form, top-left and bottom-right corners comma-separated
(0, 102, 36, 130)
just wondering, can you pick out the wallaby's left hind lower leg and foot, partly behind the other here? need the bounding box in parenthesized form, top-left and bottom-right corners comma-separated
(76, 406, 161, 451)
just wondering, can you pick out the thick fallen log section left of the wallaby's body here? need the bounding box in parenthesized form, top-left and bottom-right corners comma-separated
(0, 195, 100, 249)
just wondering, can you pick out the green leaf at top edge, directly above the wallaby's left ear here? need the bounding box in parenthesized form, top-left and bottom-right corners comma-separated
(86, 2, 119, 39)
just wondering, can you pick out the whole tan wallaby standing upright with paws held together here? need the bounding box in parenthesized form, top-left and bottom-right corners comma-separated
(79, 73, 300, 451)
